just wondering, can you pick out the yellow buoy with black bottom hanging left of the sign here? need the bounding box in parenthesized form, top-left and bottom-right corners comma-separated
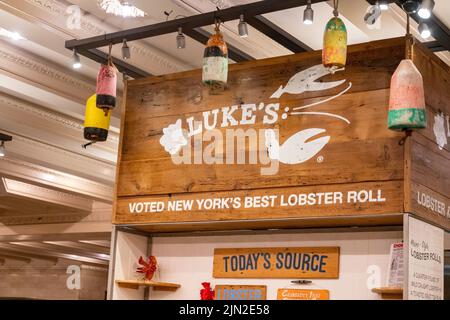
(84, 94, 111, 144)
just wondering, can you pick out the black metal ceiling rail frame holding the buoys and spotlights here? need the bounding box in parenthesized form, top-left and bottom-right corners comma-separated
(66, 0, 450, 78)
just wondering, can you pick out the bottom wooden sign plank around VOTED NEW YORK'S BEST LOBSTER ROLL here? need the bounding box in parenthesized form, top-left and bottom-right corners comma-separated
(115, 180, 403, 226)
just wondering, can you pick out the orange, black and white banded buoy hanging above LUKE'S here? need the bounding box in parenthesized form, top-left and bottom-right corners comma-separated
(202, 22, 228, 88)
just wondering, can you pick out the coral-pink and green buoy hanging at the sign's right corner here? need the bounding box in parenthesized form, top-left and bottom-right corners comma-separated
(388, 59, 427, 130)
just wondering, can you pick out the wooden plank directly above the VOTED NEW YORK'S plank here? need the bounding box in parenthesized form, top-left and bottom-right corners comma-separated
(118, 138, 403, 197)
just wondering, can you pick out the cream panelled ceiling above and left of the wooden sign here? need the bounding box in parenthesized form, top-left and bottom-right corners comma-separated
(0, 0, 450, 258)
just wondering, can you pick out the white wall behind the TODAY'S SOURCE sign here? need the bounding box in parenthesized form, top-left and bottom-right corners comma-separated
(149, 231, 403, 300)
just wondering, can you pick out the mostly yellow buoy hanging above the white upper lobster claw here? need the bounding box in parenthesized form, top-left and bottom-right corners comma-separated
(322, 16, 347, 69)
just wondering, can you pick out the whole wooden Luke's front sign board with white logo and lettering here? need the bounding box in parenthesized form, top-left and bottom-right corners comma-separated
(114, 38, 450, 232)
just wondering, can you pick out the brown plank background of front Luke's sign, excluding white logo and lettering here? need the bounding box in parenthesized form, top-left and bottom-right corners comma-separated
(114, 39, 422, 232)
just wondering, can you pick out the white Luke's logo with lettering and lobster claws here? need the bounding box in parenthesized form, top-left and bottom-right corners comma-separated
(160, 64, 352, 175)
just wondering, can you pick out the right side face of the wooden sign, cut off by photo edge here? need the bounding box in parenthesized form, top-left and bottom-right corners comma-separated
(405, 45, 450, 231)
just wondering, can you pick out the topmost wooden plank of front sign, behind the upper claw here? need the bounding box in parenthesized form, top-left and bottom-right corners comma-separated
(127, 46, 404, 120)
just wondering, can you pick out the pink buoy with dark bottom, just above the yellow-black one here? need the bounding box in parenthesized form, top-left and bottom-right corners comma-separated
(96, 63, 117, 114)
